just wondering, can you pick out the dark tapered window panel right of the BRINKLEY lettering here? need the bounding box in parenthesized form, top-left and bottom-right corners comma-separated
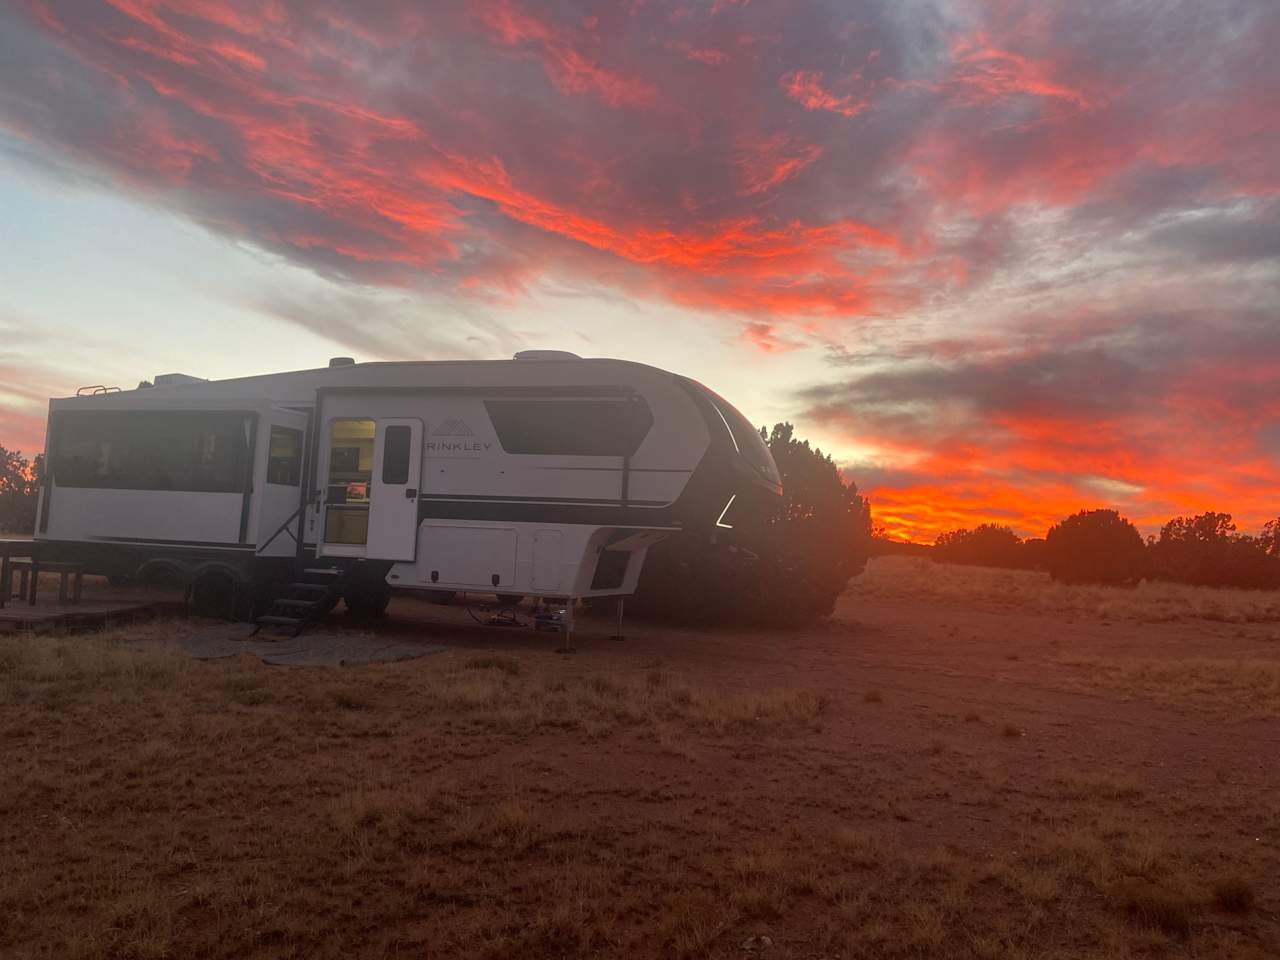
(485, 398, 653, 457)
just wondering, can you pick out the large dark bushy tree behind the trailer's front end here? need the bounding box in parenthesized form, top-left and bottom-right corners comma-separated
(626, 424, 872, 625)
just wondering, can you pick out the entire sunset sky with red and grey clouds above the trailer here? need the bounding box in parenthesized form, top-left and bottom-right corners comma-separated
(0, 0, 1280, 540)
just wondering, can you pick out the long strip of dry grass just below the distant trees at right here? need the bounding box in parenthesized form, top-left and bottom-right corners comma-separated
(850, 557, 1280, 623)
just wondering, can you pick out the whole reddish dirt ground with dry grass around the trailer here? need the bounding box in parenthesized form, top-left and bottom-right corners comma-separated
(0, 559, 1280, 960)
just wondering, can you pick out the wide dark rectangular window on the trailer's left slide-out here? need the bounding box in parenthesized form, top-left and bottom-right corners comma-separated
(51, 411, 250, 493)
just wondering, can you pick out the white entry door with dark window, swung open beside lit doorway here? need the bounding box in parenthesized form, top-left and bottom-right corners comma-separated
(365, 419, 422, 561)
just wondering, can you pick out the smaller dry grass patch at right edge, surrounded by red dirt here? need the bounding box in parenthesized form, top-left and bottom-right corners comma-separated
(1060, 655, 1280, 716)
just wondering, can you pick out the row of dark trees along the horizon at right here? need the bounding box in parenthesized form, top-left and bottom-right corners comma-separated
(929, 509, 1280, 590)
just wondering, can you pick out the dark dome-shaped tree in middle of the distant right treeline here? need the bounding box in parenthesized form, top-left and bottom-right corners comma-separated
(1044, 509, 1147, 585)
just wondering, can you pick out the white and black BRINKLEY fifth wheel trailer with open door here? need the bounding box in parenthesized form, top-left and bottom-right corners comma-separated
(36, 351, 782, 632)
